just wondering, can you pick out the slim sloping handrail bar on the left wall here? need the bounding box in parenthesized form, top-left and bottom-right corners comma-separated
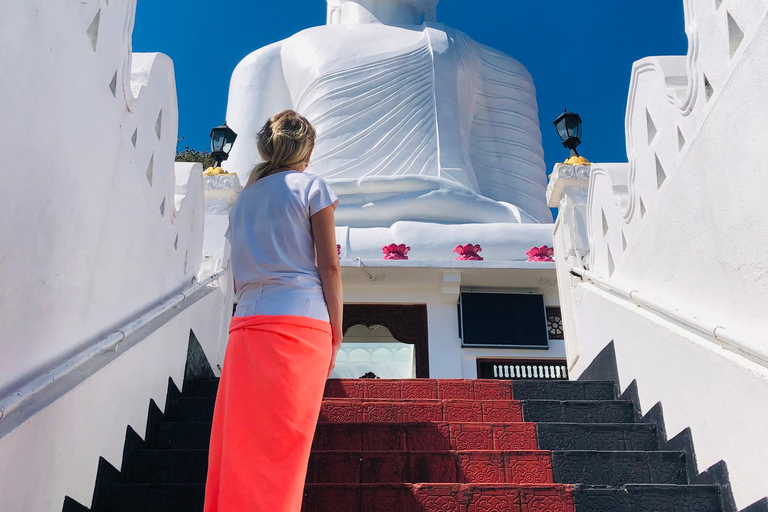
(0, 267, 228, 421)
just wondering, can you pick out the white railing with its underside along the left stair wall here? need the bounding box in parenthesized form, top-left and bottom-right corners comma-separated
(0, 267, 228, 437)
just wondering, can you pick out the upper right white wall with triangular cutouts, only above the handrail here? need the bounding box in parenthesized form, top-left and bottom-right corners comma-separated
(588, 0, 768, 345)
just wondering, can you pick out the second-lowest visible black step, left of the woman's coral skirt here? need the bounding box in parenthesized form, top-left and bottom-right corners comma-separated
(127, 449, 208, 484)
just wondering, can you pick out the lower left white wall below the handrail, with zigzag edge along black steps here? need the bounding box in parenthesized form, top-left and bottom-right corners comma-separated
(0, 287, 231, 512)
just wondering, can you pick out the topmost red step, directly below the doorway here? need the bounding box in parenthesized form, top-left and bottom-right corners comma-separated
(324, 379, 514, 400)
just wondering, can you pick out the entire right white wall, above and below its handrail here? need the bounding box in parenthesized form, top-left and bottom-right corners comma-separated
(550, 0, 768, 508)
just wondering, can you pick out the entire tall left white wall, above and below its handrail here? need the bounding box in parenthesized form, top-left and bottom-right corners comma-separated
(0, 0, 232, 512)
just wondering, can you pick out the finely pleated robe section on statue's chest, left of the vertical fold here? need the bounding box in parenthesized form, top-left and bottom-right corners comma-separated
(296, 46, 439, 179)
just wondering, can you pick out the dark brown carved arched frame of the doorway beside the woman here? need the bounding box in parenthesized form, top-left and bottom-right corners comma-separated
(344, 304, 429, 378)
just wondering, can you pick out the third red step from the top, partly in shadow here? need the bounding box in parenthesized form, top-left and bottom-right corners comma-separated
(312, 422, 538, 451)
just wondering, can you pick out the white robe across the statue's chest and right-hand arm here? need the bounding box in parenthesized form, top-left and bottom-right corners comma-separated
(230, 24, 552, 222)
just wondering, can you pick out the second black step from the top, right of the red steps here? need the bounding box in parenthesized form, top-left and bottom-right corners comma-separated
(523, 400, 635, 423)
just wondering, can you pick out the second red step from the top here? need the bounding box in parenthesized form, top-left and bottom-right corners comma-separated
(320, 398, 523, 423)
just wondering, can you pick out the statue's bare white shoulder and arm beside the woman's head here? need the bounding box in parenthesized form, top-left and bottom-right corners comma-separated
(225, 42, 293, 183)
